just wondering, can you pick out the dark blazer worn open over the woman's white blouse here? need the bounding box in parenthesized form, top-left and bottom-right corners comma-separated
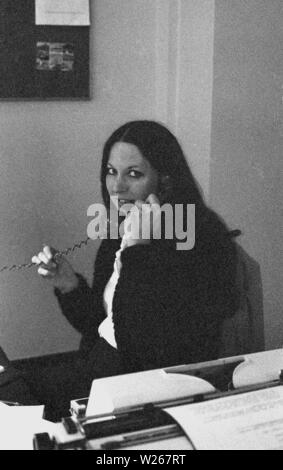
(55, 213, 237, 373)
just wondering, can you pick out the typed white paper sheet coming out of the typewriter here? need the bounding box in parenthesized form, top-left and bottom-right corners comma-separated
(166, 386, 283, 450)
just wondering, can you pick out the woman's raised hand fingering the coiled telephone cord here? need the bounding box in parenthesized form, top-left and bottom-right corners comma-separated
(31, 246, 79, 294)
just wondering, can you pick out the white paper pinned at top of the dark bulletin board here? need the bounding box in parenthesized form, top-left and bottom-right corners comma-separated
(35, 0, 90, 26)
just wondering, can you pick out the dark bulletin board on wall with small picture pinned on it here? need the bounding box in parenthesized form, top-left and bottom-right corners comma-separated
(0, 0, 89, 99)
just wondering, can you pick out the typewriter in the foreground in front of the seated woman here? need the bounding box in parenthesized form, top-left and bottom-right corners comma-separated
(34, 350, 283, 450)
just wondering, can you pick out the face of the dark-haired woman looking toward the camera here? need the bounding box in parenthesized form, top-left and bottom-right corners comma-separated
(106, 142, 158, 209)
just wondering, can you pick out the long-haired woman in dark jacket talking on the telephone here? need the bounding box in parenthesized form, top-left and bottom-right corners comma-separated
(33, 121, 240, 418)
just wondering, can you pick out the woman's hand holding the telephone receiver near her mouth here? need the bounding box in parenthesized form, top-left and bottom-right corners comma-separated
(124, 194, 161, 247)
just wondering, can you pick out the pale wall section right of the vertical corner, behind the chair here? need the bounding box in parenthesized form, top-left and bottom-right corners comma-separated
(210, 0, 283, 349)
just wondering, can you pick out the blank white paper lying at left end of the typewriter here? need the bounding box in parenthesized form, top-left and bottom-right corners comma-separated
(0, 403, 56, 450)
